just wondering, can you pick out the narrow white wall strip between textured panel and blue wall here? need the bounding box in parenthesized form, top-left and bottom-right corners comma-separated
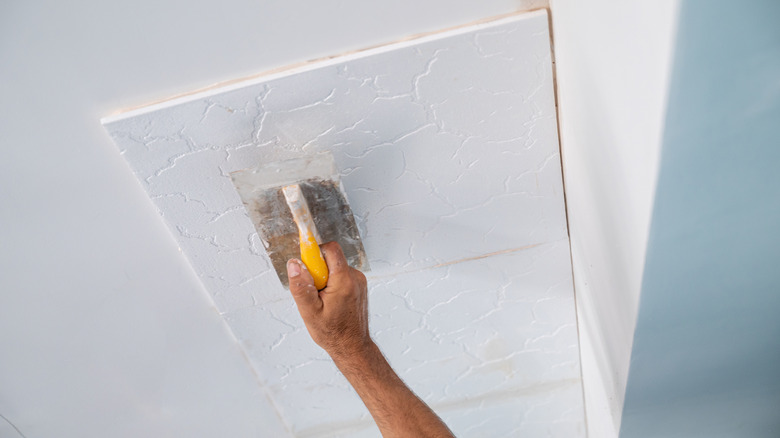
(551, 0, 677, 438)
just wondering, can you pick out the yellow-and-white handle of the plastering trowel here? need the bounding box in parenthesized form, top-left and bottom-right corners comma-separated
(282, 184, 328, 290)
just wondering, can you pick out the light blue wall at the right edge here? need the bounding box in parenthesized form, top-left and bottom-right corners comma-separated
(620, 1, 780, 438)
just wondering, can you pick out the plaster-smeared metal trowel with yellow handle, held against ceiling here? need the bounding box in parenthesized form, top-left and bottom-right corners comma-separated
(230, 152, 369, 289)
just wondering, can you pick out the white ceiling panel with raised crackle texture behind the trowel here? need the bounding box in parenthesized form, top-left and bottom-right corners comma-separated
(105, 11, 585, 437)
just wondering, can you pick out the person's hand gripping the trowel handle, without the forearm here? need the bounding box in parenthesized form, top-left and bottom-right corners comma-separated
(287, 242, 372, 359)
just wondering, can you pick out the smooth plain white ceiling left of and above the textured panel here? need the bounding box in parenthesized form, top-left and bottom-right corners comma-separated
(0, 0, 548, 438)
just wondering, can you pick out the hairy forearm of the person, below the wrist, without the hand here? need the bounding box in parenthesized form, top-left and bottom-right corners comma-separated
(331, 342, 453, 438)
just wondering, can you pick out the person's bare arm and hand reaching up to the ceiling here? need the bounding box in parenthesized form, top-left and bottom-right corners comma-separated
(287, 242, 453, 438)
